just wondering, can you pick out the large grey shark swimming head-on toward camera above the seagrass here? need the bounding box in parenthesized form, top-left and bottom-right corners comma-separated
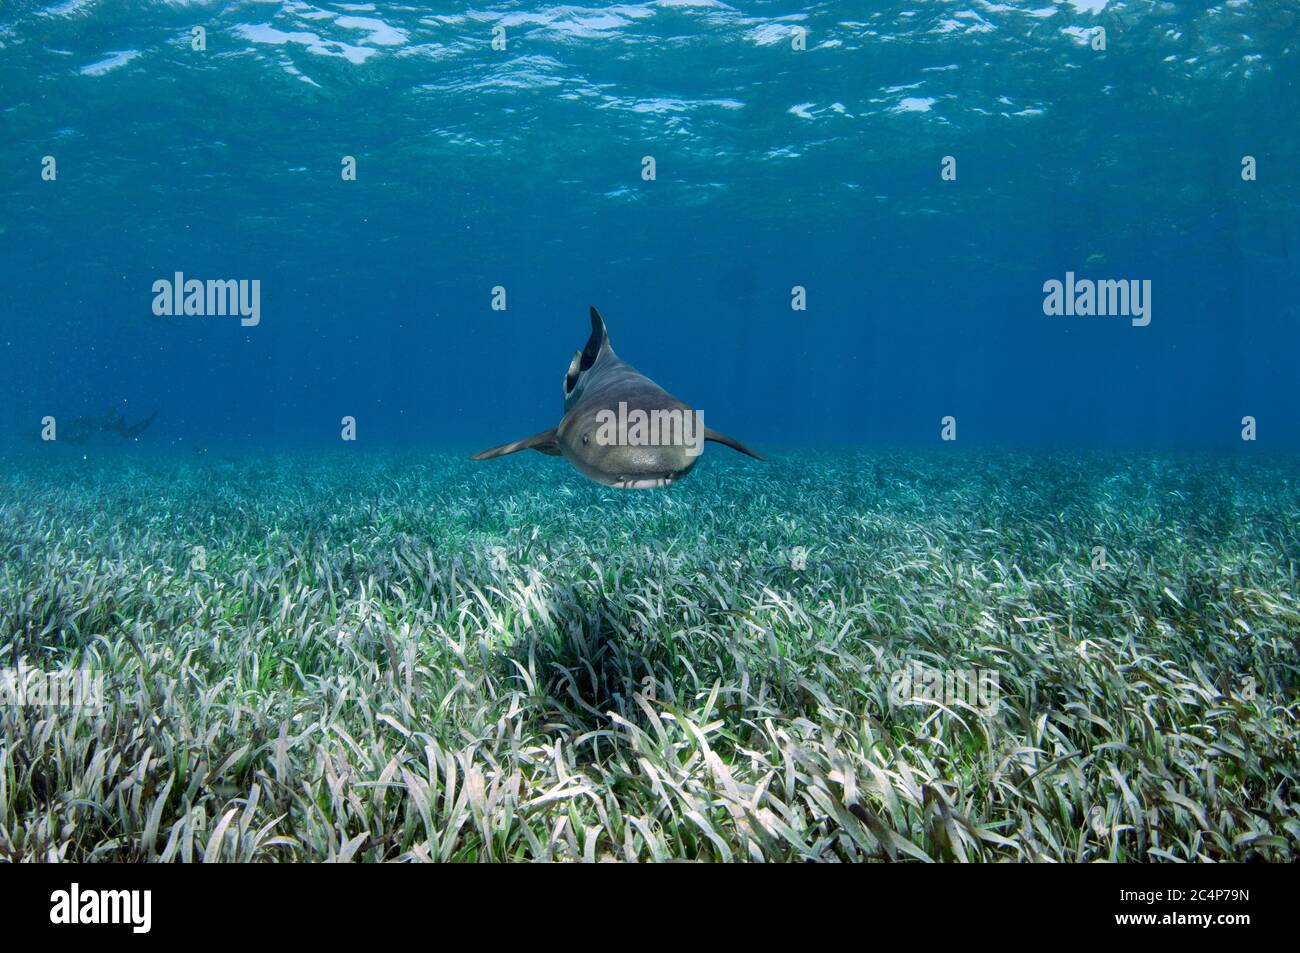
(471, 308, 763, 490)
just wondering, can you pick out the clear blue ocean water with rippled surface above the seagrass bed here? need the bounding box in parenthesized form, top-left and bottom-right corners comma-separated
(0, 0, 1300, 452)
